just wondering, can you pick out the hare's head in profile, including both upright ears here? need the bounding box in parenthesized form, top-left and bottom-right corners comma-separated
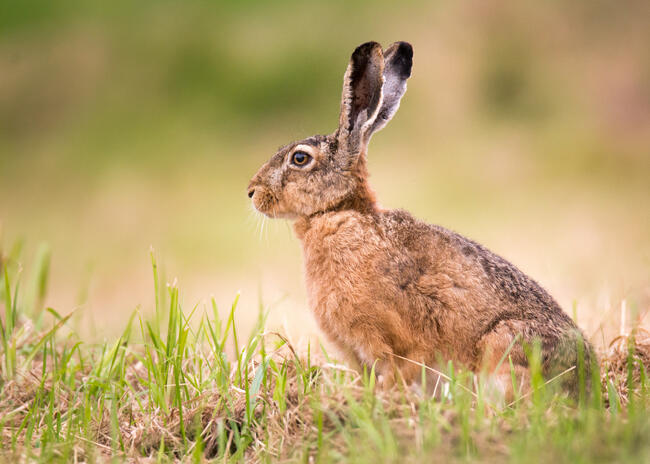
(248, 42, 413, 218)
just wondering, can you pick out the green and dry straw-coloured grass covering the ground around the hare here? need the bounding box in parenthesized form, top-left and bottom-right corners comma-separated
(0, 249, 650, 463)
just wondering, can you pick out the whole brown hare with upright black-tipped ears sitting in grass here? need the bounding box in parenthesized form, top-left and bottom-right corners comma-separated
(248, 42, 595, 397)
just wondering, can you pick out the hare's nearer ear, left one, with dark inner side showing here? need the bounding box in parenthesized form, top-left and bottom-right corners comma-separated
(338, 42, 384, 158)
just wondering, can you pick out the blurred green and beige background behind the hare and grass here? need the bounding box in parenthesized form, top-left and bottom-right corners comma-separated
(0, 0, 650, 343)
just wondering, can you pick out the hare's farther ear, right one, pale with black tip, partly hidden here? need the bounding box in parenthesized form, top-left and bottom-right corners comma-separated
(370, 42, 413, 135)
